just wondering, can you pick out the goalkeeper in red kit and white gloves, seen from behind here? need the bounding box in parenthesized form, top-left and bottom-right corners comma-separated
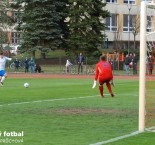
(92, 56, 114, 98)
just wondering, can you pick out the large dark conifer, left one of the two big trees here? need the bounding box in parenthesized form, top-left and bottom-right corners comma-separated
(12, 0, 66, 58)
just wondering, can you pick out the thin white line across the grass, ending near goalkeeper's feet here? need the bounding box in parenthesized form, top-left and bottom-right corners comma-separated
(0, 95, 99, 107)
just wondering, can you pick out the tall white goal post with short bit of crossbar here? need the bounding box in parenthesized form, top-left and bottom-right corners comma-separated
(139, 1, 155, 132)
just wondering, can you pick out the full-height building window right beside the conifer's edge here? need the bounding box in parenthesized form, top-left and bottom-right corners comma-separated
(105, 14, 117, 31)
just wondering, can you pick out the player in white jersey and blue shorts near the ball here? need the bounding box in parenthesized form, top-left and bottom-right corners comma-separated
(0, 52, 12, 86)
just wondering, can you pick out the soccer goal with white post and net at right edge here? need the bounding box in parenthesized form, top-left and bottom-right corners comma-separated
(139, 1, 155, 131)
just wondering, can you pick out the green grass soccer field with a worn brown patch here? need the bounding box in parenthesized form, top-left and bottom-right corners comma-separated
(0, 77, 155, 145)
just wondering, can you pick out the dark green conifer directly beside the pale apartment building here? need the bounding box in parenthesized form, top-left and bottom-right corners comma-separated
(66, 0, 109, 53)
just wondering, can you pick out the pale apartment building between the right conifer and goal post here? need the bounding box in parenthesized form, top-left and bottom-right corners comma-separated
(105, 0, 151, 51)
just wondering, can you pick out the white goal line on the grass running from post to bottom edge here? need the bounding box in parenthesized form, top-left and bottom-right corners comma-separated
(90, 131, 141, 145)
